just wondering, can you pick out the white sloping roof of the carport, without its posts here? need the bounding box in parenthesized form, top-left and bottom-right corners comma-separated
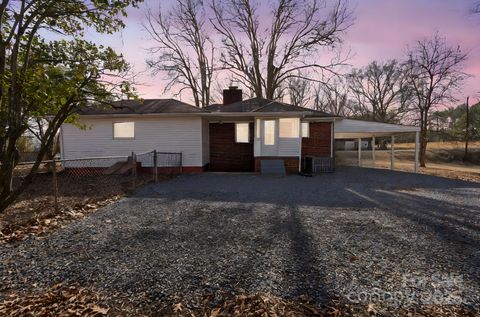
(335, 118, 420, 139)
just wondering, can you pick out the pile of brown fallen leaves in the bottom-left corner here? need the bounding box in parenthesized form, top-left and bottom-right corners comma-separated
(0, 284, 110, 317)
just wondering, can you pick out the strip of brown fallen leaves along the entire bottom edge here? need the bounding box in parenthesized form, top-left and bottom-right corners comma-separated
(0, 283, 479, 317)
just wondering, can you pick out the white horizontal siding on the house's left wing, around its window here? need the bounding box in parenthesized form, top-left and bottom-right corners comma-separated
(62, 117, 203, 166)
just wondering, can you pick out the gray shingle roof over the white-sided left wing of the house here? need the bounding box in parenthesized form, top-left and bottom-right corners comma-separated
(79, 99, 206, 115)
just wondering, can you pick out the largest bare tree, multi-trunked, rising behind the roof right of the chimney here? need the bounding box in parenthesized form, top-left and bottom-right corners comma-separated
(212, 0, 351, 99)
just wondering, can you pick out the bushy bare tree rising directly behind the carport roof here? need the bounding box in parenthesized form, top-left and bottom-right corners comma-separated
(348, 60, 407, 122)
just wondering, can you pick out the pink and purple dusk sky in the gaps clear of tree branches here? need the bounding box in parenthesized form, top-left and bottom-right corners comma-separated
(83, 0, 480, 101)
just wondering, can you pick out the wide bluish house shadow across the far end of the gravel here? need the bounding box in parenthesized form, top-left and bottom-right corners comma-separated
(136, 167, 480, 208)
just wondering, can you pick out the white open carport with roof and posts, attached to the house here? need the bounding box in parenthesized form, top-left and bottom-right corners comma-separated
(335, 119, 420, 173)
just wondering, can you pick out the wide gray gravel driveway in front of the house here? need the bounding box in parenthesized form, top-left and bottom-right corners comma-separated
(0, 167, 480, 308)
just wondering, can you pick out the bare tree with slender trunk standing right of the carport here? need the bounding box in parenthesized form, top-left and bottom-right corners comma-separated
(405, 33, 468, 167)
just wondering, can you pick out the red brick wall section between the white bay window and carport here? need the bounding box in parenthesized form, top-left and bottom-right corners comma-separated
(302, 122, 332, 157)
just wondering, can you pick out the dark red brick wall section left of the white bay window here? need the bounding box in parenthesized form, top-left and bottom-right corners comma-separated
(209, 123, 255, 172)
